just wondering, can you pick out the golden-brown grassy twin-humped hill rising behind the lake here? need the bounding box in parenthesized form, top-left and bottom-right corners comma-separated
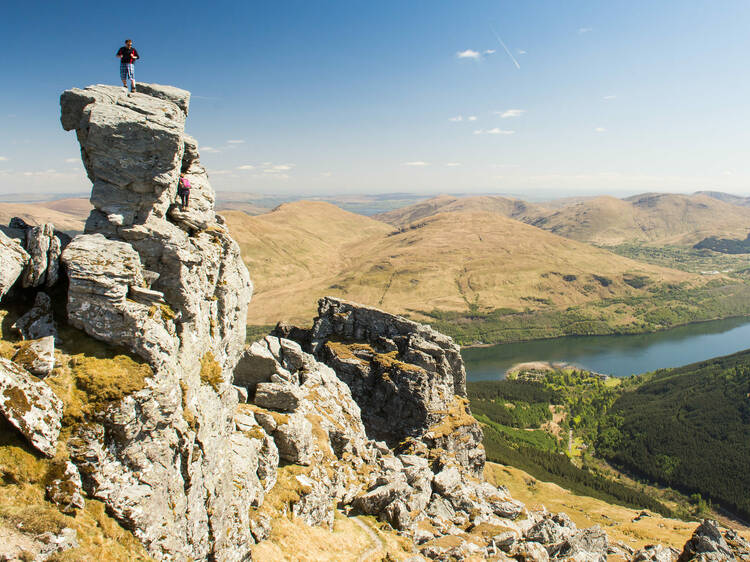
(226, 202, 716, 332)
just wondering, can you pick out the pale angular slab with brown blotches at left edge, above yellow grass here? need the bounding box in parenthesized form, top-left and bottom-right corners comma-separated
(0, 357, 63, 457)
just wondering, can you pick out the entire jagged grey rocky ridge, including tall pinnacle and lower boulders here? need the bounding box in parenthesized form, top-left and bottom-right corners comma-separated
(0, 84, 747, 561)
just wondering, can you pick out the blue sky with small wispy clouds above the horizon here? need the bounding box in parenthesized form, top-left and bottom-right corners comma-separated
(0, 0, 750, 199)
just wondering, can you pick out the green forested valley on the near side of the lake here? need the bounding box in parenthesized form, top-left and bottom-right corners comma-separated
(468, 351, 750, 528)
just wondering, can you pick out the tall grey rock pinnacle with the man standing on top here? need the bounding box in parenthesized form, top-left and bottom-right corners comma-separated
(60, 84, 253, 561)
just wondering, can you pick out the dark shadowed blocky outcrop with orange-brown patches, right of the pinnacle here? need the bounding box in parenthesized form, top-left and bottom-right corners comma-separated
(278, 297, 484, 476)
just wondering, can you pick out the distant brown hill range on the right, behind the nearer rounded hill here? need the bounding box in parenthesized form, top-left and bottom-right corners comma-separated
(375, 193, 750, 246)
